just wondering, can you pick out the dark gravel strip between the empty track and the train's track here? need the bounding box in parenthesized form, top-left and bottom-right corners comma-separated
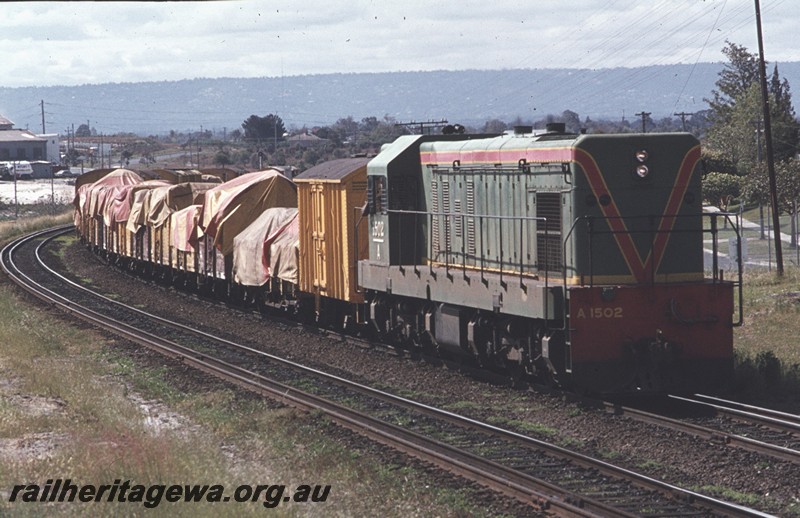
(61, 239, 800, 514)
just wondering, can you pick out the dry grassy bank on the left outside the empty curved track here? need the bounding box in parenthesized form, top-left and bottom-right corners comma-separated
(0, 216, 500, 518)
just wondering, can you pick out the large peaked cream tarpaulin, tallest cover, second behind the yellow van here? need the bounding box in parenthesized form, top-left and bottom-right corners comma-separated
(198, 169, 297, 255)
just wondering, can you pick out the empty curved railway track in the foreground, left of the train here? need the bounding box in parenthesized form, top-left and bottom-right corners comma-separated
(2, 228, 767, 516)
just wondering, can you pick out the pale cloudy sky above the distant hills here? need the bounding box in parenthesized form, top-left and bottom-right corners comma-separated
(0, 0, 800, 87)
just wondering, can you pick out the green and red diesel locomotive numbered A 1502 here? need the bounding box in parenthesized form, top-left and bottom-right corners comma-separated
(359, 125, 741, 393)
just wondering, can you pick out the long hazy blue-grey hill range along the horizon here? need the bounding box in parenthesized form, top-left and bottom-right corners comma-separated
(0, 62, 800, 135)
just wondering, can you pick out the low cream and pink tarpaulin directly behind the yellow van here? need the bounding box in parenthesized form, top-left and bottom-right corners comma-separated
(233, 208, 299, 286)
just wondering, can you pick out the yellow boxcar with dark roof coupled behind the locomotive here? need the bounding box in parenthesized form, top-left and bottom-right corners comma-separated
(294, 158, 369, 303)
